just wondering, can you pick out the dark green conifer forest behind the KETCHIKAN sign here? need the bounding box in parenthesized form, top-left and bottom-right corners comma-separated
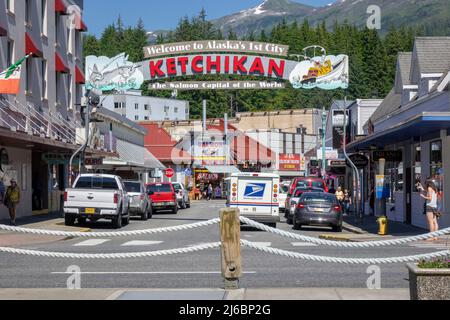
(85, 11, 434, 118)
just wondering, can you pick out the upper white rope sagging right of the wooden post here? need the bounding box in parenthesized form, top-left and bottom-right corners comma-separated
(240, 216, 450, 248)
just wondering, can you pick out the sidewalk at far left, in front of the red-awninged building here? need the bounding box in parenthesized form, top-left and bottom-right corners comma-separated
(0, 214, 91, 247)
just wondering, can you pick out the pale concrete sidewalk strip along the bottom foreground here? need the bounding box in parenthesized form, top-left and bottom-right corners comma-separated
(0, 288, 410, 301)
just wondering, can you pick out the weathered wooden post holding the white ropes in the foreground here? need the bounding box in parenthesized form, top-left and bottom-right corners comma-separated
(220, 208, 242, 290)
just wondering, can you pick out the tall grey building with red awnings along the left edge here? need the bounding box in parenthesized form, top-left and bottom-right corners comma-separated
(0, 0, 91, 218)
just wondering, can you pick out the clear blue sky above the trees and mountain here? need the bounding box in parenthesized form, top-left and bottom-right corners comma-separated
(84, 0, 333, 35)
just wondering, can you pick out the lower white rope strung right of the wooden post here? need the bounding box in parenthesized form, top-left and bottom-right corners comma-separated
(241, 240, 450, 265)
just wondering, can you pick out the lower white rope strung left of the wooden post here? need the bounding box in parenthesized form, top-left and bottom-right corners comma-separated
(0, 242, 221, 260)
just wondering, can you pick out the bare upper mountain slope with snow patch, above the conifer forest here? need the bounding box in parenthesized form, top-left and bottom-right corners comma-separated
(213, 0, 450, 36)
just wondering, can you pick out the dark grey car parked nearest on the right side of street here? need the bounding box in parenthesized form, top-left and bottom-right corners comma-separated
(293, 192, 343, 232)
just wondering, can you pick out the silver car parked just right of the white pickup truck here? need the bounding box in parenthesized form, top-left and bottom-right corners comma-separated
(123, 181, 153, 221)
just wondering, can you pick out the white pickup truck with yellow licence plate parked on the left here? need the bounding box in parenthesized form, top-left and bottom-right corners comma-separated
(64, 174, 130, 229)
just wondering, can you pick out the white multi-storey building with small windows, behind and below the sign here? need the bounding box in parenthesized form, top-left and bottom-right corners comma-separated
(102, 90, 189, 121)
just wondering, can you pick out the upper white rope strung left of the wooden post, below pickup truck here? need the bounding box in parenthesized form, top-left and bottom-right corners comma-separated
(0, 218, 220, 238)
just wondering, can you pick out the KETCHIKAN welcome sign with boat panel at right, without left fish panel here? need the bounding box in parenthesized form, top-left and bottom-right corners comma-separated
(136, 40, 349, 90)
